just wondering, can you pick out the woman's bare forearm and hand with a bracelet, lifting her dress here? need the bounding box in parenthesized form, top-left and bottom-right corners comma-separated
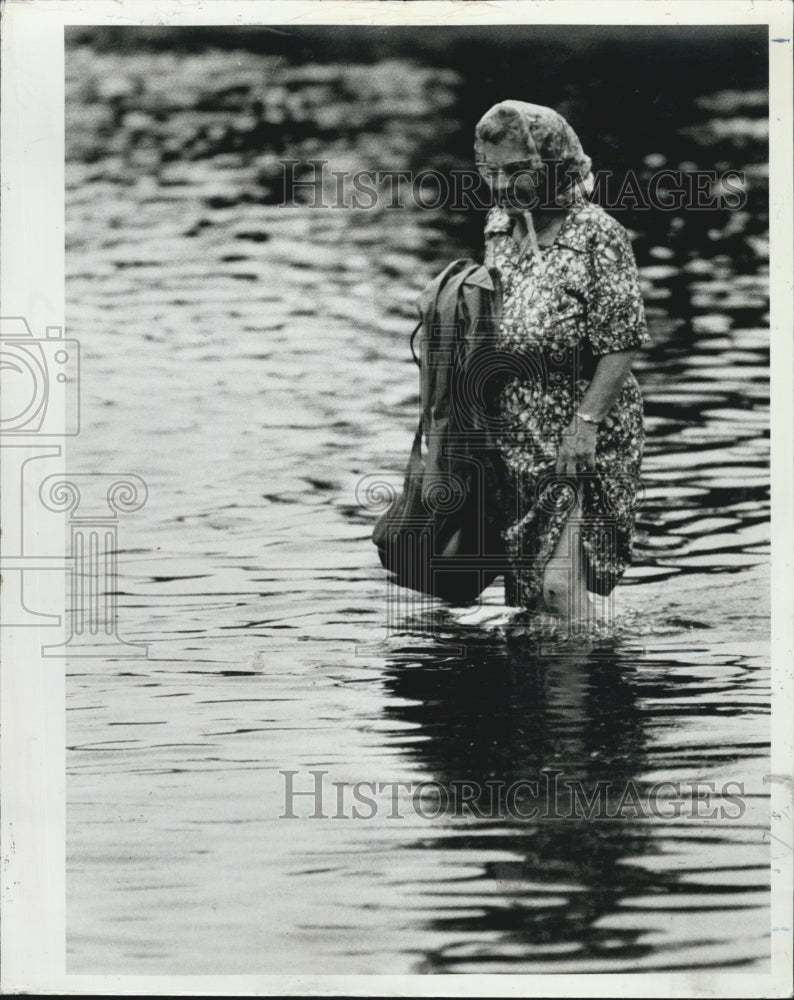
(556, 348, 637, 476)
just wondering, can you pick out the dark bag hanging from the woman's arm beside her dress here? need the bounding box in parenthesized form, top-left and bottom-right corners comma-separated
(372, 261, 502, 604)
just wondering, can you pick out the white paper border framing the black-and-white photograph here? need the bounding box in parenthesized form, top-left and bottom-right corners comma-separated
(0, 0, 794, 997)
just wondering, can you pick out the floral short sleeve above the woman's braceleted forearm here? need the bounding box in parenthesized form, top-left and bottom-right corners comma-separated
(587, 220, 650, 355)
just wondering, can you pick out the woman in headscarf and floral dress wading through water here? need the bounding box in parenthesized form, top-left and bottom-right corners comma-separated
(475, 101, 648, 619)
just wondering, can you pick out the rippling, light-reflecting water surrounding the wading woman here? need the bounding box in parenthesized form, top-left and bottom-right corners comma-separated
(66, 47, 770, 974)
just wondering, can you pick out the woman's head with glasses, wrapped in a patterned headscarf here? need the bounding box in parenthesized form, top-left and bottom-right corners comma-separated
(474, 101, 591, 207)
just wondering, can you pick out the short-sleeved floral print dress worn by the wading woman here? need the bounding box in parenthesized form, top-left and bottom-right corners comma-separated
(485, 202, 649, 609)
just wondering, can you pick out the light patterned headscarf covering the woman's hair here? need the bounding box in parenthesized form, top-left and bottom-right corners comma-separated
(474, 101, 593, 205)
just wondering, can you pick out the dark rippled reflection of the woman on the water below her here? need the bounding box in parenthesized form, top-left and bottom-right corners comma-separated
(387, 642, 650, 972)
